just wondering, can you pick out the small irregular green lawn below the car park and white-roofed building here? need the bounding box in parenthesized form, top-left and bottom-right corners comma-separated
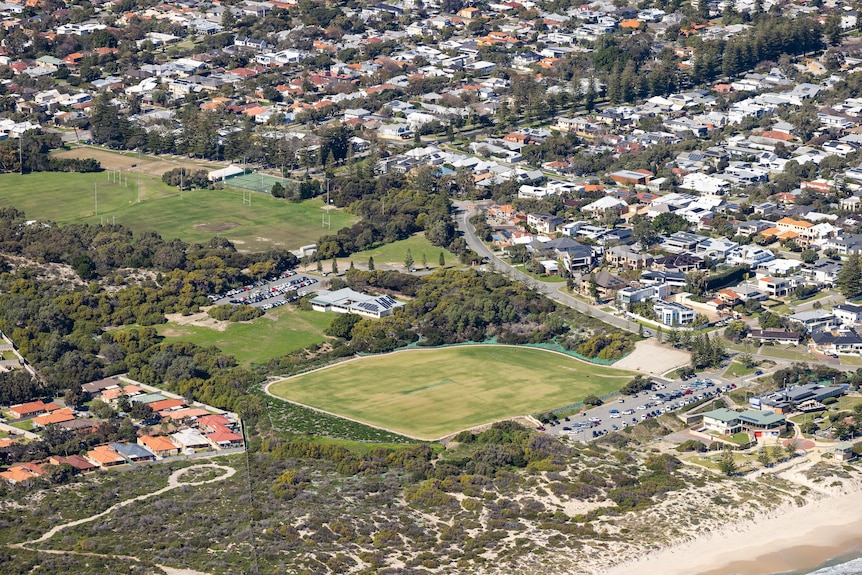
(157, 305, 335, 365)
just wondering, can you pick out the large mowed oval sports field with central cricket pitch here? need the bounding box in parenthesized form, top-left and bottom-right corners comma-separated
(269, 346, 635, 439)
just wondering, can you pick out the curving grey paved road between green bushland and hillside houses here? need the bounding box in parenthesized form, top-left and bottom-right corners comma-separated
(455, 202, 640, 333)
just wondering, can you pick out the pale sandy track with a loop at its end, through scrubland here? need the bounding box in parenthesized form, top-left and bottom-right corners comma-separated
(9, 463, 236, 575)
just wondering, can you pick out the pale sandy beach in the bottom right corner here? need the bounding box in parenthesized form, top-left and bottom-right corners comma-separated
(601, 490, 862, 575)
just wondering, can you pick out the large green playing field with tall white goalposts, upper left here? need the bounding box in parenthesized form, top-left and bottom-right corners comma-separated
(0, 172, 354, 251)
